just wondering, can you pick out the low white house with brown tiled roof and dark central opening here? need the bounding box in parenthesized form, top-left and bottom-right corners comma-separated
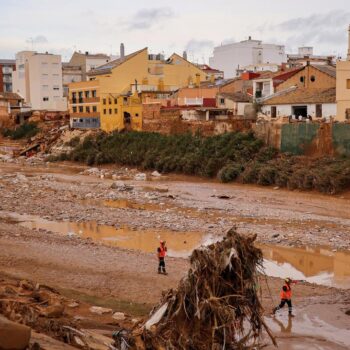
(261, 86, 337, 120)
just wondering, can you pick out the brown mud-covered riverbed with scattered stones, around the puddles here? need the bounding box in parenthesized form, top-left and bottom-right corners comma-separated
(0, 163, 350, 349)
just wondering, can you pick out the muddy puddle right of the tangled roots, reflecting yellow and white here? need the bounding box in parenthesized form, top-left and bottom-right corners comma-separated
(259, 245, 350, 288)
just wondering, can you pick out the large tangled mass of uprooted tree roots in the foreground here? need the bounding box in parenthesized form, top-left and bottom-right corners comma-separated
(137, 229, 274, 350)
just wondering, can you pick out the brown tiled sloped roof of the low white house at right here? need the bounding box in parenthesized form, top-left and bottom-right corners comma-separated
(263, 88, 336, 105)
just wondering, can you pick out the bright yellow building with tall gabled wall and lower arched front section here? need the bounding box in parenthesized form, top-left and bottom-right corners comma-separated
(70, 48, 207, 132)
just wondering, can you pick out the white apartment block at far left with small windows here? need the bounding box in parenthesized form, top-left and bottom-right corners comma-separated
(12, 51, 68, 111)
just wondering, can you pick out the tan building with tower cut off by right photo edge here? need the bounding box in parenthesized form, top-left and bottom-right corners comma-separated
(337, 26, 350, 121)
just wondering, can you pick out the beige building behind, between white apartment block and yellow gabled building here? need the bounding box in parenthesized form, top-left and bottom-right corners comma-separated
(67, 51, 111, 81)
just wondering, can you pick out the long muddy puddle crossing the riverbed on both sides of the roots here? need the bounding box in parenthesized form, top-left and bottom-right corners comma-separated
(0, 209, 350, 288)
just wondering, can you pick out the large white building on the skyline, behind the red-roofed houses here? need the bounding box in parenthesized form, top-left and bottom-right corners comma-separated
(209, 37, 287, 78)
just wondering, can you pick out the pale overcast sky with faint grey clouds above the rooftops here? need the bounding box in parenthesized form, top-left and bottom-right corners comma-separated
(0, 0, 350, 63)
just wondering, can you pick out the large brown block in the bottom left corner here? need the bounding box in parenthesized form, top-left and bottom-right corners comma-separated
(0, 315, 31, 350)
